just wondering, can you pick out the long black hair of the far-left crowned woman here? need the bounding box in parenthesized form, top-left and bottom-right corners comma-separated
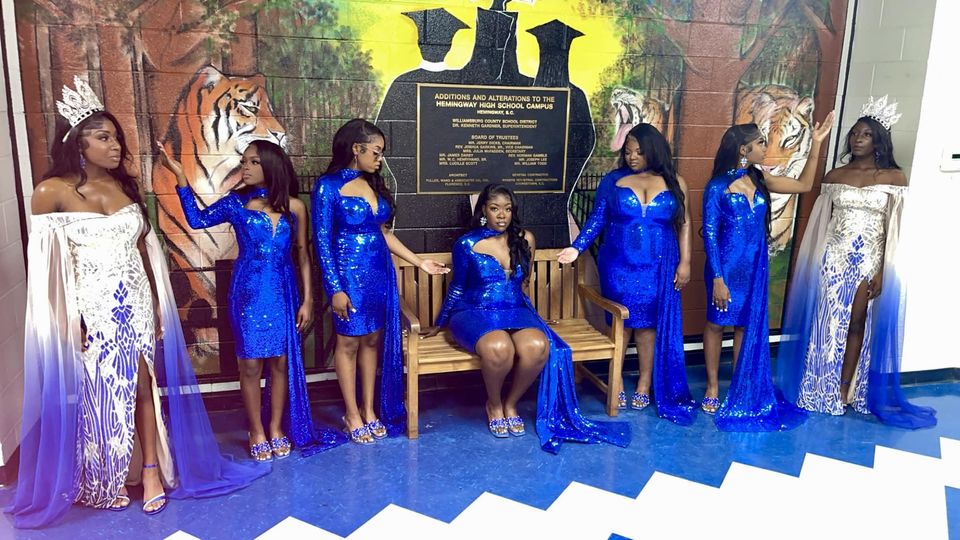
(41, 111, 150, 231)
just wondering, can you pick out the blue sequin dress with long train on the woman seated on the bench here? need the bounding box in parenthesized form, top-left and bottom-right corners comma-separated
(436, 227, 630, 454)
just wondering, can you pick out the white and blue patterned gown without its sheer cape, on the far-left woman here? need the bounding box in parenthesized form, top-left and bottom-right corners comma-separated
(48, 204, 173, 508)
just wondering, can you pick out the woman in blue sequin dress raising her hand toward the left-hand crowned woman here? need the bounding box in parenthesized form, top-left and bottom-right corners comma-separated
(160, 141, 345, 461)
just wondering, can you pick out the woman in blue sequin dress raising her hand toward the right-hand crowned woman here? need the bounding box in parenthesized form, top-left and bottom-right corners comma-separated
(702, 112, 833, 431)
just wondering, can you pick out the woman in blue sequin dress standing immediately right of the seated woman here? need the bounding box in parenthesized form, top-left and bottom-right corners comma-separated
(558, 124, 696, 425)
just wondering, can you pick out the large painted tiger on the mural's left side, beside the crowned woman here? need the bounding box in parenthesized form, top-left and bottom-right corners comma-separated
(153, 65, 287, 369)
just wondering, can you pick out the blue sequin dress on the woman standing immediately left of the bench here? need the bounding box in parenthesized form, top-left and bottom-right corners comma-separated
(313, 169, 406, 435)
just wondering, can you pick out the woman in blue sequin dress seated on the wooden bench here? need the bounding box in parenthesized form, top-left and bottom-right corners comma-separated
(424, 184, 630, 453)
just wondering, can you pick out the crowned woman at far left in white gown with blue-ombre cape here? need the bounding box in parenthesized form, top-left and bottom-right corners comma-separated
(7, 79, 269, 528)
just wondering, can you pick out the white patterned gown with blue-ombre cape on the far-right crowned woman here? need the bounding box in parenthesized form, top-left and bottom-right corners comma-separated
(775, 184, 937, 429)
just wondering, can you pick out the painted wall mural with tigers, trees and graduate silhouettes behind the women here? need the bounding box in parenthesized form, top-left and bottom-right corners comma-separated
(16, 0, 846, 375)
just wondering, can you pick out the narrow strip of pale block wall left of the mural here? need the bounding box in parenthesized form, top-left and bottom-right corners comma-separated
(0, 0, 27, 465)
